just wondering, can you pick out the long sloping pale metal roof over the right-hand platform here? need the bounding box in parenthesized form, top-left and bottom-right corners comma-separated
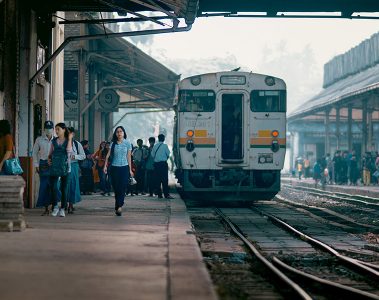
(288, 64, 379, 120)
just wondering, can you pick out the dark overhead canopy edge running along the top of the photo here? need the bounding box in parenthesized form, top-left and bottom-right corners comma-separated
(22, 0, 379, 24)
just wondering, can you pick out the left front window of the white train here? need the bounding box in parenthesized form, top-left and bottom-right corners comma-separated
(179, 90, 216, 112)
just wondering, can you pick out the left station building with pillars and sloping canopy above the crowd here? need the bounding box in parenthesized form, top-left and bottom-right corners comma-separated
(0, 0, 197, 207)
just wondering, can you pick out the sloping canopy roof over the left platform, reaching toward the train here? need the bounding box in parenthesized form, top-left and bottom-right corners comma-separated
(88, 25, 180, 109)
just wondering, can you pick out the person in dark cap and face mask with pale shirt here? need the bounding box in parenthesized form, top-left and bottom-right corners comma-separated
(33, 121, 54, 216)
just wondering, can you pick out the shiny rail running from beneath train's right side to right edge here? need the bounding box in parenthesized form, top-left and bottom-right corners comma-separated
(252, 207, 379, 280)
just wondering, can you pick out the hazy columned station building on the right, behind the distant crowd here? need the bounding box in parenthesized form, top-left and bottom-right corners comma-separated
(287, 33, 379, 168)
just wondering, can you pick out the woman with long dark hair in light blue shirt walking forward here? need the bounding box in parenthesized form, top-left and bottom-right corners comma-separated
(104, 126, 134, 216)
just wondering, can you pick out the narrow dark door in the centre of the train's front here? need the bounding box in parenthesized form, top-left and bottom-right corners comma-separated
(219, 93, 246, 163)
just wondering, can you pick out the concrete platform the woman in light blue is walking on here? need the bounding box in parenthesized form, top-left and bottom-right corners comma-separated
(0, 194, 217, 300)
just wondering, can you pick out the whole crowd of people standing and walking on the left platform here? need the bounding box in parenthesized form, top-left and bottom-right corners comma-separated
(0, 120, 172, 217)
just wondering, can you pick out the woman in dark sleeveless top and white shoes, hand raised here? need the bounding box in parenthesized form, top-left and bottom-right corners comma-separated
(48, 123, 73, 217)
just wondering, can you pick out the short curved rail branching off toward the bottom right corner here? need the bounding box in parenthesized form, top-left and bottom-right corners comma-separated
(272, 256, 379, 300)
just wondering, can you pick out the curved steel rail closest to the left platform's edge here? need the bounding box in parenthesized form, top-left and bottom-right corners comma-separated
(215, 208, 312, 299)
